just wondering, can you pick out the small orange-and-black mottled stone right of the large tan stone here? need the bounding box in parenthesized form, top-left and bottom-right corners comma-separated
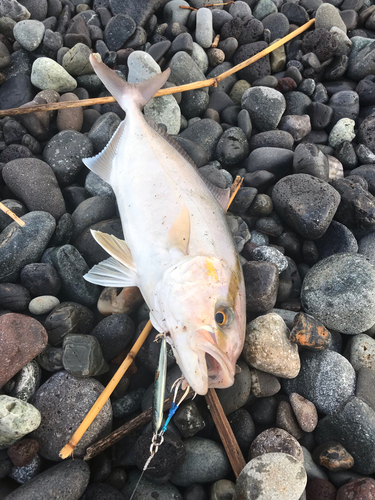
(289, 313, 331, 351)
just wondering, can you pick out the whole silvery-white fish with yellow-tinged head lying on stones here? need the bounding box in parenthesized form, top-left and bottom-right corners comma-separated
(83, 54, 246, 395)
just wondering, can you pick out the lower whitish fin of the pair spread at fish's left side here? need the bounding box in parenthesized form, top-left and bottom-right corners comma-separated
(84, 257, 137, 288)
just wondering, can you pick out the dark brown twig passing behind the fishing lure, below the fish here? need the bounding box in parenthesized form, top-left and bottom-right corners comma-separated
(83, 390, 194, 460)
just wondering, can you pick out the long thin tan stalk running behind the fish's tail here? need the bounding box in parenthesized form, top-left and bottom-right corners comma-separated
(0, 19, 315, 118)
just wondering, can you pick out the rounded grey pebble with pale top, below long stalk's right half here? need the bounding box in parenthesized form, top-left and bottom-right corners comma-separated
(241, 87, 286, 132)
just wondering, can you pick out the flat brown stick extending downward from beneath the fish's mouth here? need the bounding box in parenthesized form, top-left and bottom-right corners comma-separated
(205, 389, 246, 477)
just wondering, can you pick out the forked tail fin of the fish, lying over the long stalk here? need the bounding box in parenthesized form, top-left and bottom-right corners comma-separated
(90, 54, 171, 112)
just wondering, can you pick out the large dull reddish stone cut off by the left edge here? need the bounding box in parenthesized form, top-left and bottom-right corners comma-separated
(0, 313, 48, 387)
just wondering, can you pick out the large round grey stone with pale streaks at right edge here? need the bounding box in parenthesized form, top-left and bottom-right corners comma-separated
(301, 253, 375, 335)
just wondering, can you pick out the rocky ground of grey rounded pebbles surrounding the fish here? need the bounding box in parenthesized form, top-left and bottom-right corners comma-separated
(0, 0, 375, 500)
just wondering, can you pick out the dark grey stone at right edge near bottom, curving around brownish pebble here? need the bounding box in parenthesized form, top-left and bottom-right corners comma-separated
(315, 397, 375, 475)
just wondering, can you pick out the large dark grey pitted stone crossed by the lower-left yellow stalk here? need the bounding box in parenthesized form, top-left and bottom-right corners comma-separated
(31, 371, 112, 463)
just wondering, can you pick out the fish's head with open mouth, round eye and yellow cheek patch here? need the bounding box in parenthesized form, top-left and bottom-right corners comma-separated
(156, 255, 246, 395)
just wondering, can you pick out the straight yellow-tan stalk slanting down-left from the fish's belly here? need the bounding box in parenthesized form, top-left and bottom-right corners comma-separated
(59, 320, 152, 458)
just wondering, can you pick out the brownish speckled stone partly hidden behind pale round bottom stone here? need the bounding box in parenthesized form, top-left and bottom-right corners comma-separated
(249, 427, 303, 463)
